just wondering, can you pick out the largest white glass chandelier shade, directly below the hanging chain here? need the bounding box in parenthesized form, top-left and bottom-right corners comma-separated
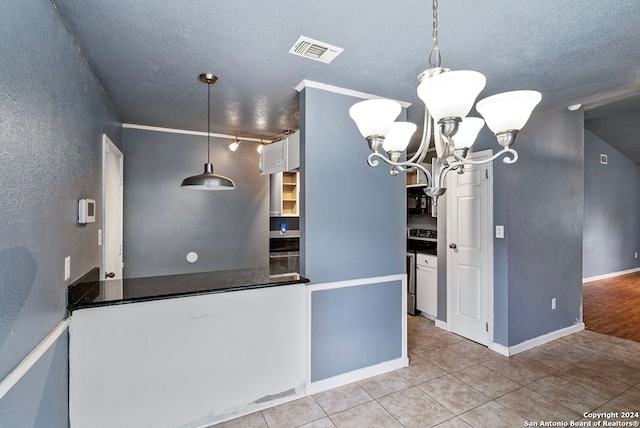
(418, 70, 487, 122)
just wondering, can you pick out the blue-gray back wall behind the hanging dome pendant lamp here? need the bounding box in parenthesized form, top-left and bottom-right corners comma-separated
(123, 128, 269, 278)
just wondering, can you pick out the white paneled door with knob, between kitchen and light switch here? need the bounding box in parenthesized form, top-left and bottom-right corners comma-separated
(447, 150, 493, 345)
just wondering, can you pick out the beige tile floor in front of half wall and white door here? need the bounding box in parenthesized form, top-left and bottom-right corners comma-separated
(215, 316, 640, 428)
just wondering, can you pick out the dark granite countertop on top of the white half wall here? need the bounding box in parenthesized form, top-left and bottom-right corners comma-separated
(67, 267, 309, 312)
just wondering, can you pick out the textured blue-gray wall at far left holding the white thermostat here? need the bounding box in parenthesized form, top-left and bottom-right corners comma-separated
(0, 0, 122, 427)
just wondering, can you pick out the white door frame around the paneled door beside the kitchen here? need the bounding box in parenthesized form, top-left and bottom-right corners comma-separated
(445, 149, 494, 348)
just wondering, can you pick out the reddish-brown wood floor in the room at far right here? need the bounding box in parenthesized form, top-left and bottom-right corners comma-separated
(582, 272, 640, 342)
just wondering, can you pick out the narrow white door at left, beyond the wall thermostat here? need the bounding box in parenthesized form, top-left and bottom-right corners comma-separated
(102, 135, 123, 279)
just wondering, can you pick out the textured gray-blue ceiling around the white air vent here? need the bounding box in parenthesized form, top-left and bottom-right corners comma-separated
(52, 0, 640, 164)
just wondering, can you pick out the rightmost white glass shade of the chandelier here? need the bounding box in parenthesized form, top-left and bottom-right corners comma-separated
(476, 91, 542, 134)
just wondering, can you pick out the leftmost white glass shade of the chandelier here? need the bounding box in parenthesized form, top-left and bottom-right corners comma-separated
(349, 99, 402, 138)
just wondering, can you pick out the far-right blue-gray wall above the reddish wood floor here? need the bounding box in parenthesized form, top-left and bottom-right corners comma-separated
(582, 131, 640, 278)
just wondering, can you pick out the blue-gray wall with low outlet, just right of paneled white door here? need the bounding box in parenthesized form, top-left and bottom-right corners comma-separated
(504, 110, 584, 346)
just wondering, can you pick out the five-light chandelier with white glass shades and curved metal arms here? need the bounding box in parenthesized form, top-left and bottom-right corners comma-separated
(349, 0, 542, 203)
